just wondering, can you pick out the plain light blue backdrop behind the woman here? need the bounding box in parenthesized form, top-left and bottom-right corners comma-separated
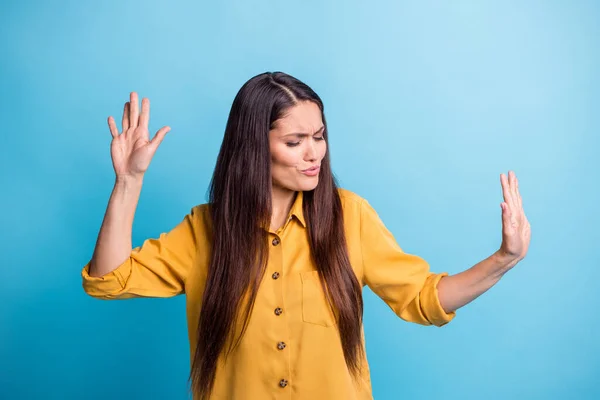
(0, 0, 600, 400)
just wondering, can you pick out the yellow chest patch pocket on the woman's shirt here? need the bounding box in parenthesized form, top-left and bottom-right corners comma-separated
(300, 271, 335, 326)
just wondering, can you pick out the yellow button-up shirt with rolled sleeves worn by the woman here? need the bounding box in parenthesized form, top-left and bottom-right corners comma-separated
(82, 189, 455, 400)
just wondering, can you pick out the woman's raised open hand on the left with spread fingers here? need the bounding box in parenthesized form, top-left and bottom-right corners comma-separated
(108, 92, 171, 178)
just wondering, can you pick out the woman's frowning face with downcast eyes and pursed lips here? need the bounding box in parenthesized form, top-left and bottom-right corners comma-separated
(269, 101, 327, 191)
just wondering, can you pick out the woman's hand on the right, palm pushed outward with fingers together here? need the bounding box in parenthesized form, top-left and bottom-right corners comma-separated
(499, 171, 531, 268)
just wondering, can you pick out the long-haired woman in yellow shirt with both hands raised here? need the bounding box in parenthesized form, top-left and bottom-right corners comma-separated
(82, 73, 530, 400)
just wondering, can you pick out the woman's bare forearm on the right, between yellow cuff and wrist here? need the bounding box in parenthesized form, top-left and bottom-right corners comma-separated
(437, 251, 516, 313)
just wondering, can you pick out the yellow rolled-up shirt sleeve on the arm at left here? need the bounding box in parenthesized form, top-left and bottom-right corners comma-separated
(81, 206, 201, 300)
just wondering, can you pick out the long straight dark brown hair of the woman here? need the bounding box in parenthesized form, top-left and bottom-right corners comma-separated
(190, 72, 364, 399)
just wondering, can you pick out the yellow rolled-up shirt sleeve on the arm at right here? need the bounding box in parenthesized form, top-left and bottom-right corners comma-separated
(360, 199, 456, 326)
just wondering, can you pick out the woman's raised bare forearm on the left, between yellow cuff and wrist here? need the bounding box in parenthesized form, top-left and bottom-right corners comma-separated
(89, 177, 143, 276)
